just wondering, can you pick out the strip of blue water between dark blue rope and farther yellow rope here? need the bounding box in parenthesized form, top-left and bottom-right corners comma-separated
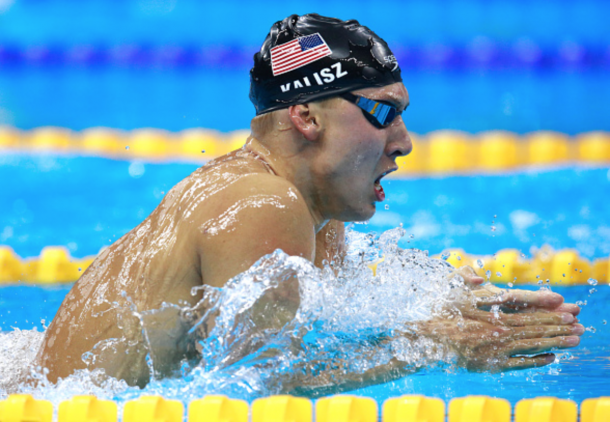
(0, 65, 610, 135)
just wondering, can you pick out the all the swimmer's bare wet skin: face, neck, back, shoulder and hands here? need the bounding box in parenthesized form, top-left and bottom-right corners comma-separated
(38, 84, 582, 388)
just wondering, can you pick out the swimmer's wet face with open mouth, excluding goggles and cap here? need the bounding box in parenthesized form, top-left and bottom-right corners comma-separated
(317, 83, 412, 221)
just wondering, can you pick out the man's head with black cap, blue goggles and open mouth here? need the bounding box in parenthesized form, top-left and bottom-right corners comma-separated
(250, 15, 411, 221)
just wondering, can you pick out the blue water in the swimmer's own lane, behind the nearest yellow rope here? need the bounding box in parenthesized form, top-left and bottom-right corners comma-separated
(0, 260, 610, 405)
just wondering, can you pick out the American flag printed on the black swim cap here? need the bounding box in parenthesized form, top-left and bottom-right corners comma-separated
(271, 33, 332, 76)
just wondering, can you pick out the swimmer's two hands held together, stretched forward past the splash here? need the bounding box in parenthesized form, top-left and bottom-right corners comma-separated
(418, 267, 584, 370)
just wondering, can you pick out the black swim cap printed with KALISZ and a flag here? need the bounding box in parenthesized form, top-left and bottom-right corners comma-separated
(250, 13, 402, 116)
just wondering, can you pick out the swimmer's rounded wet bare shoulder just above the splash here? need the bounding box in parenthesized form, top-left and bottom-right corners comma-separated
(191, 173, 315, 286)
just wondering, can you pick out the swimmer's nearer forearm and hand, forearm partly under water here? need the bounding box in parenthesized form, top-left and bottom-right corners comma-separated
(282, 309, 584, 397)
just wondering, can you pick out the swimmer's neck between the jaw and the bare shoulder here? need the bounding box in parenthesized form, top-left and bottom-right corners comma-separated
(243, 135, 329, 233)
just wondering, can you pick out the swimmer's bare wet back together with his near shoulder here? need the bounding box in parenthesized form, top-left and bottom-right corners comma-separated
(39, 150, 315, 385)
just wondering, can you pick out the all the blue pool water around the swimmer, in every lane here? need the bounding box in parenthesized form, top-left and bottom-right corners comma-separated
(0, 0, 610, 404)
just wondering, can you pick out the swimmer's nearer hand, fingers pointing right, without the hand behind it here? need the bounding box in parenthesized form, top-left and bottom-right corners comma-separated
(417, 310, 584, 371)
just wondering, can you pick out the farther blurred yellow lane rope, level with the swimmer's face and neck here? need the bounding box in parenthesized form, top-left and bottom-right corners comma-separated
(0, 126, 610, 172)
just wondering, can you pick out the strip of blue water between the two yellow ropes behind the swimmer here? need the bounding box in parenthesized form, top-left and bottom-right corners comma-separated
(0, 154, 610, 259)
